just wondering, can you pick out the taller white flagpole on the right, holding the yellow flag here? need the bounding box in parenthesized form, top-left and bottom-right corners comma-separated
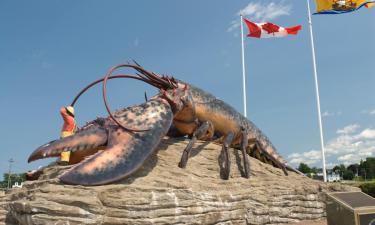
(307, 0, 327, 182)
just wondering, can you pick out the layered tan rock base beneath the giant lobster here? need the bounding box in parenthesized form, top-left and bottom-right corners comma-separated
(7, 140, 357, 224)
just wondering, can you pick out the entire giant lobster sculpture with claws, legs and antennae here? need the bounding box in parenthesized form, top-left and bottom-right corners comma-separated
(28, 63, 299, 185)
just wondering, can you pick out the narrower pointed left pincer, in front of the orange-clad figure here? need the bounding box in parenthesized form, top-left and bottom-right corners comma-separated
(28, 125, 107, 162)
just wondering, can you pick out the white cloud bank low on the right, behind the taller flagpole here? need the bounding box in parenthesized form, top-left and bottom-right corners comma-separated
(288, 124, 375, 167)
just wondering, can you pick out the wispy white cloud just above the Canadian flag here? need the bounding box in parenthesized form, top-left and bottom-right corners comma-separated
(227, 1, 292, 32)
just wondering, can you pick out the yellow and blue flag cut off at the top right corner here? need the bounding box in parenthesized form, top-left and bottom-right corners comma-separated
(314, 0, 375, 14)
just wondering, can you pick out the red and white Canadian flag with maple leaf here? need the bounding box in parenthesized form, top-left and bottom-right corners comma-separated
(244, 18, 302, 38)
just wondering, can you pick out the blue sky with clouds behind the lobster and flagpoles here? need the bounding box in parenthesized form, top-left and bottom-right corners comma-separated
(0, 0, 375, 177)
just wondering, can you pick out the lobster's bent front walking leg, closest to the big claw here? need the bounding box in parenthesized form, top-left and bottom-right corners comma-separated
(178, 121, 213, 168)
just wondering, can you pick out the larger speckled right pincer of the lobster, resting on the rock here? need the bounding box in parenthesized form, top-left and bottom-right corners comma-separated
(60, 99, 173, 185)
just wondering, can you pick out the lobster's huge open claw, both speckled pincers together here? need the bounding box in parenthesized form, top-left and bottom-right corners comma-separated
(28, 98, 173, 185)
